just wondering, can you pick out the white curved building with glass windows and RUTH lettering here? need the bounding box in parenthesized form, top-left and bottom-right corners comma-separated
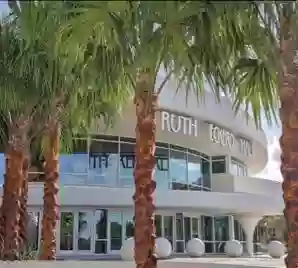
(24, 75, 283, 256)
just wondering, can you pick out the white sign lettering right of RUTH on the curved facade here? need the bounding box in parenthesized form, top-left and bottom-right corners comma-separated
(209, 124, 252, 156)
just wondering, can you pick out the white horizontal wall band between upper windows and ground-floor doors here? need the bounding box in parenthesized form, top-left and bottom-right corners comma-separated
(28, 184, 283, 215)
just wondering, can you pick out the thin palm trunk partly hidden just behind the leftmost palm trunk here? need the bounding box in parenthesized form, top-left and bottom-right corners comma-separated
(19, 155, 30, 250)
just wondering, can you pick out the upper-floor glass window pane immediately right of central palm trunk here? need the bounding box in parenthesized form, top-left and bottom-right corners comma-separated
(154, 147, 169, 190)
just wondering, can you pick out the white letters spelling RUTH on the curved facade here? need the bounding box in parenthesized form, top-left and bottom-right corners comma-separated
(161, 111, 198, 137)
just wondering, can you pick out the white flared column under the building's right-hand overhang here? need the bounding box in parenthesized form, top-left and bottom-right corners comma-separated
(236, 215, 262, 256)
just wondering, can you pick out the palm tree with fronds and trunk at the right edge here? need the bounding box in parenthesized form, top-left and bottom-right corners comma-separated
(219, 1, 298, 268)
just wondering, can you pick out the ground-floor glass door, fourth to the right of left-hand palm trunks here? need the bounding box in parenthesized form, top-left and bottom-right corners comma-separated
(108, 212, 124, 253)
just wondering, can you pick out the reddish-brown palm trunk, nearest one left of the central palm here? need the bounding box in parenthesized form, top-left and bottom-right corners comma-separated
(40, 119, 60, 260)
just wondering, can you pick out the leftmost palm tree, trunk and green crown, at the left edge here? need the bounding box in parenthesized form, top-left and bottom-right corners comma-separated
(0, 21, 44, 260)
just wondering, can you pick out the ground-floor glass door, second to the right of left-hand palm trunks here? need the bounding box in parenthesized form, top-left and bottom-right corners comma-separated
(75, 210, 93, 253)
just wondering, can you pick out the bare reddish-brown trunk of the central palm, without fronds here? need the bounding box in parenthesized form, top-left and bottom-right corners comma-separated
(133, 72, 157, 268)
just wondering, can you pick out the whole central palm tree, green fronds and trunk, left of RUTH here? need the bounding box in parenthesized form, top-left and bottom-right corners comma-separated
(59, 1, 269, 268)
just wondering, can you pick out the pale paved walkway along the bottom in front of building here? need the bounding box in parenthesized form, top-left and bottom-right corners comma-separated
(0, 257, 285, 268)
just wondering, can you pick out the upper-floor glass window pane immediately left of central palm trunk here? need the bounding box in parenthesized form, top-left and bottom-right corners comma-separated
(119, 143, 135, 187)
